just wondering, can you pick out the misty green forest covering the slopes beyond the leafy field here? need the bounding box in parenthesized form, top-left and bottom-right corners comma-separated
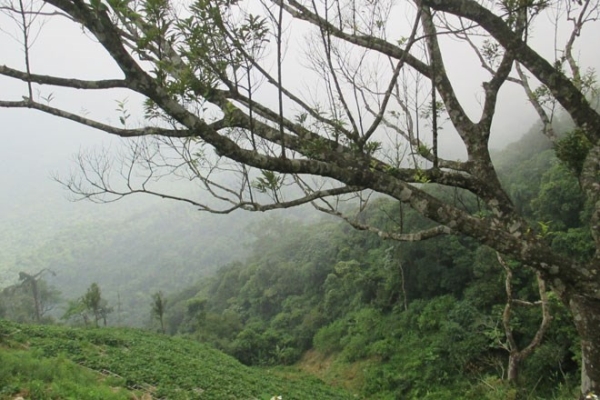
(0, 120, 593, 399)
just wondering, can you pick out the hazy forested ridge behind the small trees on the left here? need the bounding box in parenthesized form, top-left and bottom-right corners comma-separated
(2, 202, 256, 327)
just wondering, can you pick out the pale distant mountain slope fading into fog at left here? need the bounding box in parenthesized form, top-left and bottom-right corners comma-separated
(0, 164, 324, 326)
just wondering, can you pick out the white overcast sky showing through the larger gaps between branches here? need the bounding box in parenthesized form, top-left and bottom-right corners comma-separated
(0, 0, 600, 225)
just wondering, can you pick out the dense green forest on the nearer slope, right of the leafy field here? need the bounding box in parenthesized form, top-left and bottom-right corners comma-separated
(157, 126, 592, 399)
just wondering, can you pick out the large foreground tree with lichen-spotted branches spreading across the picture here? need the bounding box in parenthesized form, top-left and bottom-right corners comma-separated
(0, 0, 600, 397)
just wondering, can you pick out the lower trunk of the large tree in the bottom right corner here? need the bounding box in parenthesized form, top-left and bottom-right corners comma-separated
(569, 295, 600, 399)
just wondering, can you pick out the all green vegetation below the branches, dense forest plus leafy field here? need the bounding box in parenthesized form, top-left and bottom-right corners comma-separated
(0, 126, 593, 400)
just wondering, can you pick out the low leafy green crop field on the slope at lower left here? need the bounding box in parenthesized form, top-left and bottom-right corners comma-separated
(0, 320, 355, 400)
